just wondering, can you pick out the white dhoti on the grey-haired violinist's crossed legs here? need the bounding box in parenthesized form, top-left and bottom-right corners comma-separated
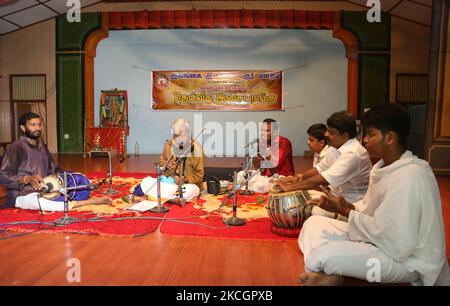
(141, 176, 200, 202)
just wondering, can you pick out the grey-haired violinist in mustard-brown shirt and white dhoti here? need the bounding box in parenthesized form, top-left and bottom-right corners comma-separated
(140, 119, 204, 201)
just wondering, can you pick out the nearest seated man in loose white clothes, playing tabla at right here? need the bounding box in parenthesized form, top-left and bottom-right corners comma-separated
(299, 103, 450, 285)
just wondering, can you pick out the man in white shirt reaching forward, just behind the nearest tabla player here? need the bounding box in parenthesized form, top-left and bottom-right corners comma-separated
(278, 111, 372, 214)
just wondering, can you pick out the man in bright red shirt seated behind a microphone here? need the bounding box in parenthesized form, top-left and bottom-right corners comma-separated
(256, 119, 295, 176)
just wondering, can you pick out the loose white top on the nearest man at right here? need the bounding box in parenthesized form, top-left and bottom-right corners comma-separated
(348, 151, 450, 285)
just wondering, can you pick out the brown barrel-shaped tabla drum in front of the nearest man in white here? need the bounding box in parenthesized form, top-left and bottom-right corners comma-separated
(267, 190, 313, 229)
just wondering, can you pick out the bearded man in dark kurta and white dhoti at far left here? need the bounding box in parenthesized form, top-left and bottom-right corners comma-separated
(0, 112, 111, 211)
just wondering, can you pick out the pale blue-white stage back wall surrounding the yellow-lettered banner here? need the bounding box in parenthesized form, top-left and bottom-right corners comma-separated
(95, 29, 347, 155)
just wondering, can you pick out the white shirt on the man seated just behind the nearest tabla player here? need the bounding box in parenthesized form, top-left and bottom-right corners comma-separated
(315, 138, 372, 203)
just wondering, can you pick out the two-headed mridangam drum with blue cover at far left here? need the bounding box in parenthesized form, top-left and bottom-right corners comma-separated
(42, 172, 91, 201)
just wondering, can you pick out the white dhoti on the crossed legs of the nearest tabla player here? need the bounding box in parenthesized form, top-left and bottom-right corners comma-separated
(298, 216, 419, 283)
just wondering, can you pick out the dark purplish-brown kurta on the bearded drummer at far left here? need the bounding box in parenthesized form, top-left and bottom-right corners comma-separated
(0, 136, 62, 205)
